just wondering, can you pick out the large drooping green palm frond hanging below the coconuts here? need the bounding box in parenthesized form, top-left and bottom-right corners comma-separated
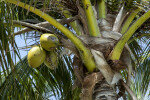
(0, 53, 80, 100)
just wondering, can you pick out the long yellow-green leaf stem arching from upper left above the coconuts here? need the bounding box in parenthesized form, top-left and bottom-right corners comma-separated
(5, 0, 96, 72)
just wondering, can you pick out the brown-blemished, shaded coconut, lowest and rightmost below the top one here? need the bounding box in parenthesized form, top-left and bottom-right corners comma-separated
(44, 51, 57, 70)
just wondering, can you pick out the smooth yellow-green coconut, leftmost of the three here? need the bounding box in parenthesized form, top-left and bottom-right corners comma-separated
(28, 46, 46, 68)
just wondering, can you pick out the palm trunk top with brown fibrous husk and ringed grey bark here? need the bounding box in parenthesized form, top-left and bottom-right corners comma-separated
(80, 72, 117, 100)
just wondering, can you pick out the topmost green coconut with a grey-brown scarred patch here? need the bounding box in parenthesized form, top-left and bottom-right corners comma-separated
(40, 33, 59, 51)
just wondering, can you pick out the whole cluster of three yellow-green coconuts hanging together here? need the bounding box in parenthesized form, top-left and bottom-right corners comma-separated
(27, 33, 59, 70)
